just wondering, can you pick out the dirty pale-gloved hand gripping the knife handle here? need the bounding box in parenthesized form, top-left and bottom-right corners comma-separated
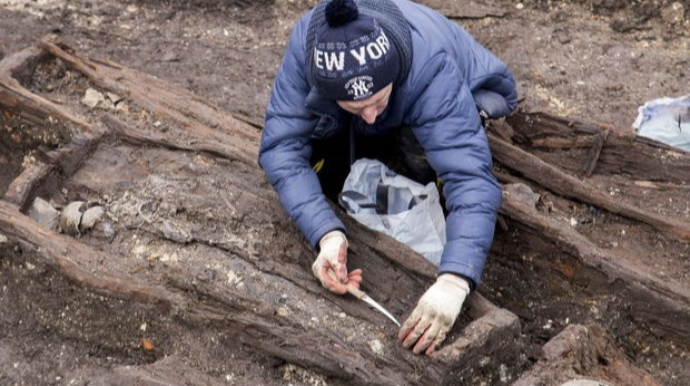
(311, 231, 362, 295)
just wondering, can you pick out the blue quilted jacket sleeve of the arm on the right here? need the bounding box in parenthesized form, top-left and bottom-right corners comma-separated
(410, 53, 501, 289)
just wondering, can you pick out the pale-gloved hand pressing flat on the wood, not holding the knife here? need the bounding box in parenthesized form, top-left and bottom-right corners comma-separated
(398, 273, 470, 355)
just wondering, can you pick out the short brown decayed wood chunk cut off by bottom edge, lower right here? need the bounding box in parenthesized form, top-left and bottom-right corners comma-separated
(512, 325, 660, 386)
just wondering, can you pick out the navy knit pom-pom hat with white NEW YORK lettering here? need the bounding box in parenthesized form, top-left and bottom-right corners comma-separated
(312, 0, 400, 101)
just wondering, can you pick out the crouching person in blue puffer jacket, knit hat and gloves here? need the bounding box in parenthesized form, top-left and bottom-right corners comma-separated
(259, 0, 517, 355)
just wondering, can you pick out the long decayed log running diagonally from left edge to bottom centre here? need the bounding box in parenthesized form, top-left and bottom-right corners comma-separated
(0, 200, 430, 385)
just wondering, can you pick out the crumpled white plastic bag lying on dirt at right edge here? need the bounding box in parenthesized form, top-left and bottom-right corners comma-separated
(633, 95, 690, 151)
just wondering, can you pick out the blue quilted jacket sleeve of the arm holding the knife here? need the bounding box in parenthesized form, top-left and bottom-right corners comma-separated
(259, 20, 345, 249)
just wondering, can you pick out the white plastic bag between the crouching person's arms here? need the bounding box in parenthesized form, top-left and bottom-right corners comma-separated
(339, 158, 446, 265)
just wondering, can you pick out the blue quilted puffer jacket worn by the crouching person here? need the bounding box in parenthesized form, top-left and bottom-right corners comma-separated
(259, 0, 517, 289)
